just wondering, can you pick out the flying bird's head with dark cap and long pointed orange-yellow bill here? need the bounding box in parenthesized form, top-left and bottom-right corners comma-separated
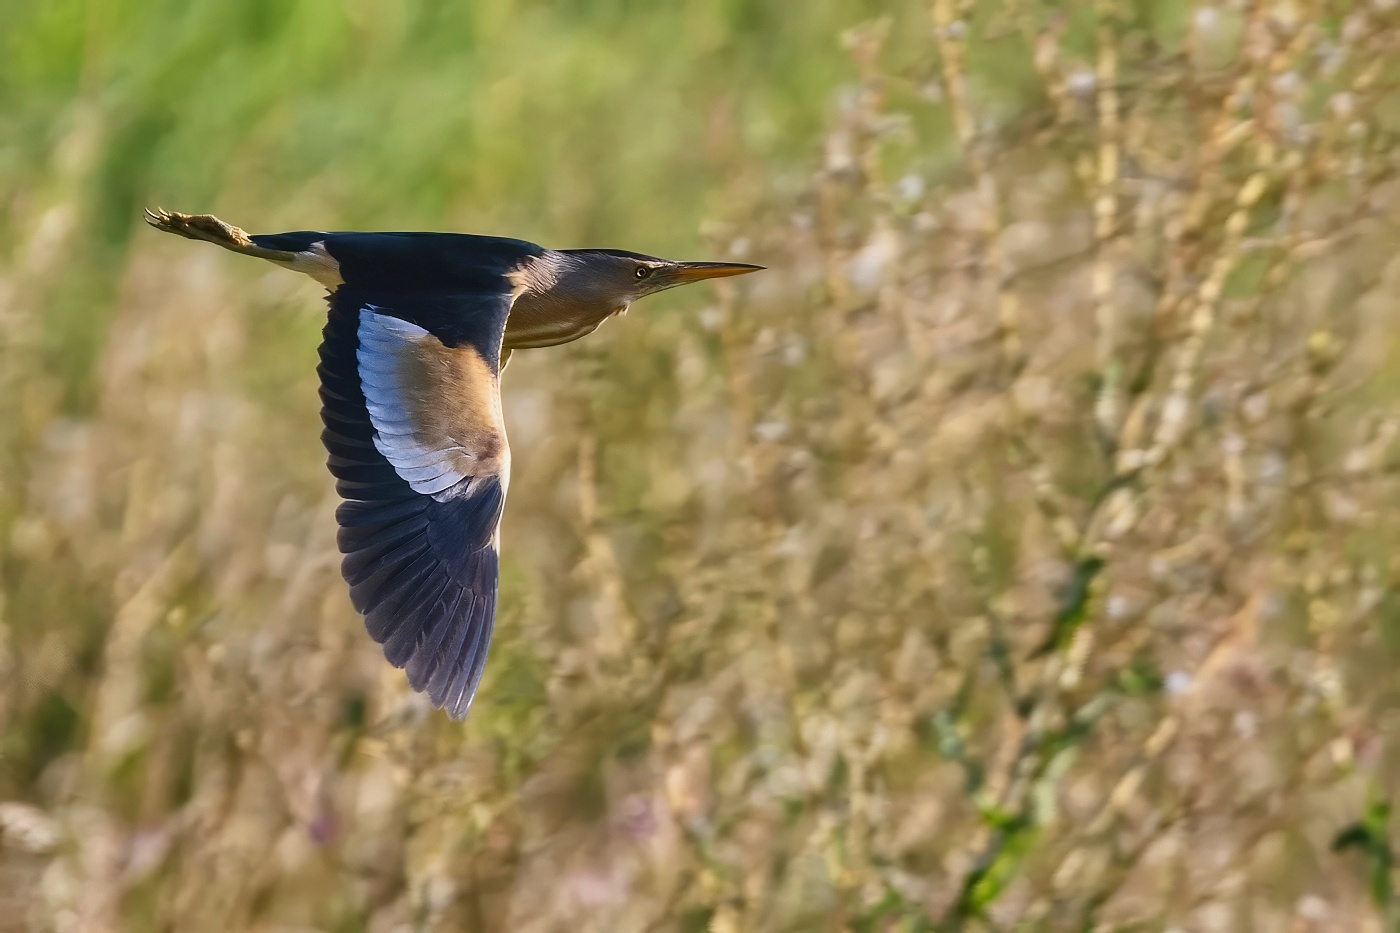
(559, 249, 763, 310)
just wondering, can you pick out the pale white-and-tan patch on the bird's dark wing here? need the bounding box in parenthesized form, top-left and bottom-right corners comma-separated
(357, 305, 510, 497)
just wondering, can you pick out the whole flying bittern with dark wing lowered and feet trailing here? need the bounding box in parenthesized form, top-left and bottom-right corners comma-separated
(146, 210, 763, 719)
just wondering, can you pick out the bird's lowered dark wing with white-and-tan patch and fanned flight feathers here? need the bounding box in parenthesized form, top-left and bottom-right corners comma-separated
(318, 284, 511, 719)
